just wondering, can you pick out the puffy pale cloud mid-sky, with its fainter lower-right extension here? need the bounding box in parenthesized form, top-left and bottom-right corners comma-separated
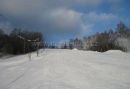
(43, 8, 94, 37)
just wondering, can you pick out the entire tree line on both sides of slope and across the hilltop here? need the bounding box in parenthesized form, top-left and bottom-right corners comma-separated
(0, 22, 130, 54)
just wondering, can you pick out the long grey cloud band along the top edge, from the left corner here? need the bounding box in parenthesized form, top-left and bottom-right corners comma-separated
(0, 0, 102, 17)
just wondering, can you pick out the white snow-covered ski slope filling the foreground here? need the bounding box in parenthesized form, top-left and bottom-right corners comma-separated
(0, 49, 130, 89)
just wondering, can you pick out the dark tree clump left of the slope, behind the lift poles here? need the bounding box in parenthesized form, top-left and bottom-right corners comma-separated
(0, 28, 44, 54)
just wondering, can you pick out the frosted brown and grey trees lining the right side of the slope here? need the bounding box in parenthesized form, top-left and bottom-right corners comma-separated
(62, 22, 130, 52)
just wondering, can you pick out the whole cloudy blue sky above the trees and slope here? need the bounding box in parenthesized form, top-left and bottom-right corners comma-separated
(0, 0, 130, 42)
